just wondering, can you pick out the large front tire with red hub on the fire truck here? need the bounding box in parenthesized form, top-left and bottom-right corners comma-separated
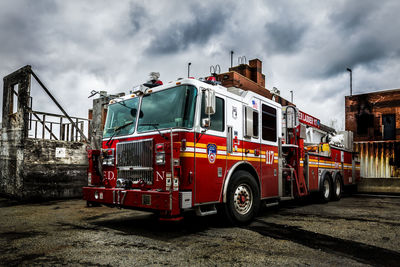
(224, 171, 260, 225)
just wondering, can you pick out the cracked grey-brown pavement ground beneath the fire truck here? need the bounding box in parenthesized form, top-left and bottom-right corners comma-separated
(0, 196, 400, 266)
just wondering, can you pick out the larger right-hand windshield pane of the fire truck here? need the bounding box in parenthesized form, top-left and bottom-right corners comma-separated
(138, 85, 197, 132)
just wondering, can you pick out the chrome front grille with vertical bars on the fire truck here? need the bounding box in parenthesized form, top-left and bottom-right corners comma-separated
(116, 139, 153, 184)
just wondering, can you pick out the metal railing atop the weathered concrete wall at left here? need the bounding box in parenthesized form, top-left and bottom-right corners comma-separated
(28, 110, 90, 142)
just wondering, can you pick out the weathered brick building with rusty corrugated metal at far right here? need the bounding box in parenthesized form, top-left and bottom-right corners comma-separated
(345, 89, 400, 178)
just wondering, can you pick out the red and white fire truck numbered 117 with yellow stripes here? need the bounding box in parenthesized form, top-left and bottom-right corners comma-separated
(83, 76, 360, 224)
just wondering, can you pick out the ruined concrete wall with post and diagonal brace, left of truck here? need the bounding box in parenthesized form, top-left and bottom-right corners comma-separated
(0, 66, 89, 199)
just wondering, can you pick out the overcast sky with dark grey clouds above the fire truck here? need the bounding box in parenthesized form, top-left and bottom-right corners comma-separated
(0, 0, 400, 130)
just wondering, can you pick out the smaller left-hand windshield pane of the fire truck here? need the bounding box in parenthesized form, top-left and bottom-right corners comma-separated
(103, 97, 139, 138)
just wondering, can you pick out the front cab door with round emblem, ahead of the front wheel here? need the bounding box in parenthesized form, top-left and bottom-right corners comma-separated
(194, 93, 227, 204)
